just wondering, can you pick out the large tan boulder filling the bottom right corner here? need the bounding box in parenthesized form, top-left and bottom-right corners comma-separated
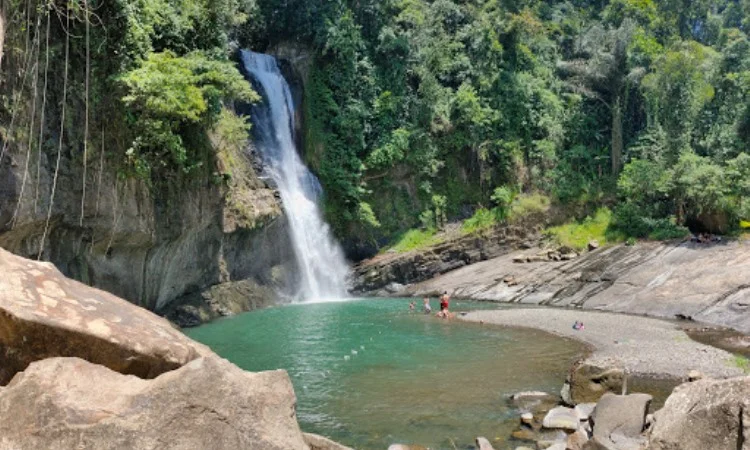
(648, 377, 750, 450)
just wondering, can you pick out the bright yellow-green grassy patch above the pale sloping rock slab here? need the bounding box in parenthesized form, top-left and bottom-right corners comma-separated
(545, 208, 624, 250)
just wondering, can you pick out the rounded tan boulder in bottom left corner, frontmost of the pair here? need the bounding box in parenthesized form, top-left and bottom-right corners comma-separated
(0, 356, 308, 450)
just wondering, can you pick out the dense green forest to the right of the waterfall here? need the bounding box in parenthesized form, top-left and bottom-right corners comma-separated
(259, 0, 750, 250)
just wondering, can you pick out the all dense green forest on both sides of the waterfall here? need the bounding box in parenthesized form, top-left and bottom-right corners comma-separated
(2, 0, 750, 255)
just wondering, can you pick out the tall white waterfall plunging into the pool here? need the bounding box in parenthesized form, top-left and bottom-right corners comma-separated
(241, 50, 348, 300)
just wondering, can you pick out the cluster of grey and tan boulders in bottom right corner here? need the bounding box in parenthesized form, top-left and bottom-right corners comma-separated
(506, 374, 750, 450)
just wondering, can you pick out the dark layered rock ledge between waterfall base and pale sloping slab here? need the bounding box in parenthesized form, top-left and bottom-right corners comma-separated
(352, 227, 536, 295)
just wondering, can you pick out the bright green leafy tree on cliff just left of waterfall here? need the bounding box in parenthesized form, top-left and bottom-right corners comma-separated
(119, 52, 258, 179)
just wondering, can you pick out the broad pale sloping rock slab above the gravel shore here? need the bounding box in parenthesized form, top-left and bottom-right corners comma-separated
(412, 241, 750, 333)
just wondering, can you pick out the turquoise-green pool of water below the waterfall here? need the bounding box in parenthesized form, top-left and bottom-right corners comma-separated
(187, 299, 583, 450)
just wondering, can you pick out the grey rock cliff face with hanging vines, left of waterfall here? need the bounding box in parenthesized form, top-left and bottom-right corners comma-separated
(0, 139, 293, 318)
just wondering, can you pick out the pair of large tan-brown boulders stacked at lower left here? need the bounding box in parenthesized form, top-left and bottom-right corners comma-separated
(0, 249, 346, 450)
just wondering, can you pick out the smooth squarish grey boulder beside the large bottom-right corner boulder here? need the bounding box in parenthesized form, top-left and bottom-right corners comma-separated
(586, 393, 652, 450)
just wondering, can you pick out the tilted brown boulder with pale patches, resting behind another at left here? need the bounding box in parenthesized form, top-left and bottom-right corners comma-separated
(0, 249, 211, 385)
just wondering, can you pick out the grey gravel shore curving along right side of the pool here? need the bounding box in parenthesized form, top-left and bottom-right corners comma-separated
(462, 308, 743, 378)
